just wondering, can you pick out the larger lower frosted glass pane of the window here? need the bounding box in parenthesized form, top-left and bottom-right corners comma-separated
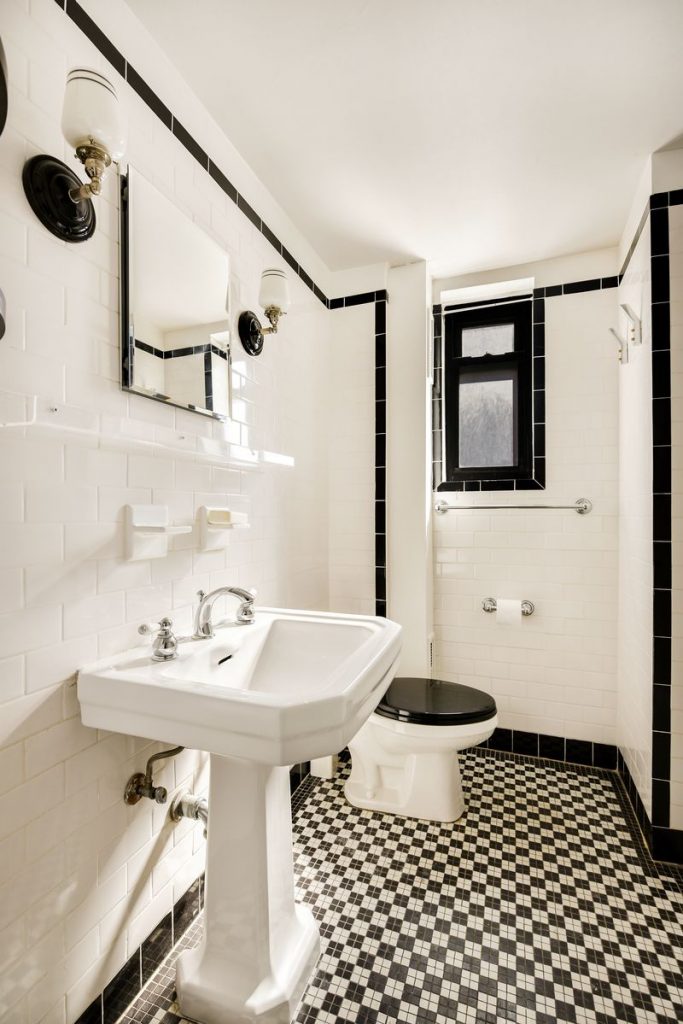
(458, 371, 517, 469)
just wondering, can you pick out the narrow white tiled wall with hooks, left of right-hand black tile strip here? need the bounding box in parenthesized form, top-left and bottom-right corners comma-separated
(615, 228, 652, 819)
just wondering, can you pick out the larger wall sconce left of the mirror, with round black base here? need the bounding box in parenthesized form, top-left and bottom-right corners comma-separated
(23, 68, 126, 242)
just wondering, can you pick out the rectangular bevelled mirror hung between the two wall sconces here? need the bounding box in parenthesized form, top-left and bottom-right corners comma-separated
(121, 167, 231, 420)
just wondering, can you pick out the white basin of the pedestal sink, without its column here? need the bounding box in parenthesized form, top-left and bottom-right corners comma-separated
(78, 608, 400, 765)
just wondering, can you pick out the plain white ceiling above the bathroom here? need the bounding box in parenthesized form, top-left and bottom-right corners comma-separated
(128, 0, 683, 275)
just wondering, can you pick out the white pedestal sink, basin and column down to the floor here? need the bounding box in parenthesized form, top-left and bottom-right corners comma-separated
(78, 608, 400, 1024)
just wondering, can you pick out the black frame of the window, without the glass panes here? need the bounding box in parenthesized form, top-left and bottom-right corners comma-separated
(444, 297, 533, 489)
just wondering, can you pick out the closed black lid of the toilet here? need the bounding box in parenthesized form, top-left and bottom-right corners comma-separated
(375, 676, 496, 725)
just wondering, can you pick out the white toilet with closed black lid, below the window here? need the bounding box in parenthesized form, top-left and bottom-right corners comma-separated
(344, 677, 498, 821)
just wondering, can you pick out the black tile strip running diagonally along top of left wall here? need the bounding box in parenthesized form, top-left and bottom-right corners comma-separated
(55, 0, 331, 309)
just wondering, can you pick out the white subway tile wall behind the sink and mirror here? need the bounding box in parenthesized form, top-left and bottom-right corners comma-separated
(0, 0, 331, 1024)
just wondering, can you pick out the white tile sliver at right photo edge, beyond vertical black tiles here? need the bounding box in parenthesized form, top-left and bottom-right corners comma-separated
(669, 206, 683, 829)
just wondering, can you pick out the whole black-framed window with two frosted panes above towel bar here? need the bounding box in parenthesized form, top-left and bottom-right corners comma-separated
(443, 300, 533, 487)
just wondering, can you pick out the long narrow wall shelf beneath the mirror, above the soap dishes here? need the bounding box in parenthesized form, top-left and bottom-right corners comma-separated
(0, 391, 294, 472)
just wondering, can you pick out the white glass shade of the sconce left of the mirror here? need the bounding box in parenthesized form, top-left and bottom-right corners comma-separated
(61, 68, 127, 161)
